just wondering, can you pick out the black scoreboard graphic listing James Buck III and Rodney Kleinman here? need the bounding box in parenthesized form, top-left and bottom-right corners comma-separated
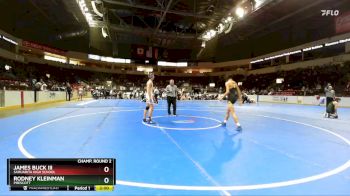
(7, 158, 116, 191)
